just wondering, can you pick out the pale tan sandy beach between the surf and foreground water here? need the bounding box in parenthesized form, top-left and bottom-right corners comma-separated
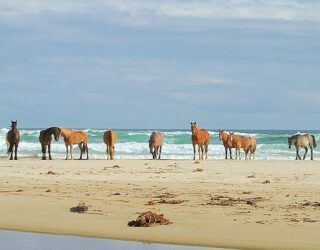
(0, 158, 320, 249)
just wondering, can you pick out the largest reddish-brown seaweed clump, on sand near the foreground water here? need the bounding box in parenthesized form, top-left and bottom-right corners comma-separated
(128, 211, 172, 227)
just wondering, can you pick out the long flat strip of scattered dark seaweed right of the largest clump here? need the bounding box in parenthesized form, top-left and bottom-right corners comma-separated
(207, 195, 265, 207)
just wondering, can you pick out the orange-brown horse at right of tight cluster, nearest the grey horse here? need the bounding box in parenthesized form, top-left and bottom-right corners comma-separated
(230, 133, 257, 160)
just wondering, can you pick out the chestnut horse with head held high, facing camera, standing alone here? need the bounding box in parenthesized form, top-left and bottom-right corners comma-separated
(191, 122, 210, 160)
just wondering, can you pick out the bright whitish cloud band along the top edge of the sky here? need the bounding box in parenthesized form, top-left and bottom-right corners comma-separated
(0, 0, 320, 25)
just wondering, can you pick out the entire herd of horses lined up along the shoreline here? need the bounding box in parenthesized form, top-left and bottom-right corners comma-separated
(6, 121, 317, 160)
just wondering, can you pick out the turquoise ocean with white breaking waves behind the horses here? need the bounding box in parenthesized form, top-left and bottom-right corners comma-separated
(0, 128, 320, 160)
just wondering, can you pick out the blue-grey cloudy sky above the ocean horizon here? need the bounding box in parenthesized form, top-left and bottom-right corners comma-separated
(0, 0, 320, 130)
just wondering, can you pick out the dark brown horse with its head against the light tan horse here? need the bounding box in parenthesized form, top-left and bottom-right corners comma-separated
(39, 127, 61, 160)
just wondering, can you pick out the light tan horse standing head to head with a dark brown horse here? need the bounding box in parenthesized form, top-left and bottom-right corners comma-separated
(61, 128, 89, 160)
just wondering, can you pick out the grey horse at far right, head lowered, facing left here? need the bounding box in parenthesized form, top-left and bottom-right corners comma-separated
(288, 134, 317, 160)
